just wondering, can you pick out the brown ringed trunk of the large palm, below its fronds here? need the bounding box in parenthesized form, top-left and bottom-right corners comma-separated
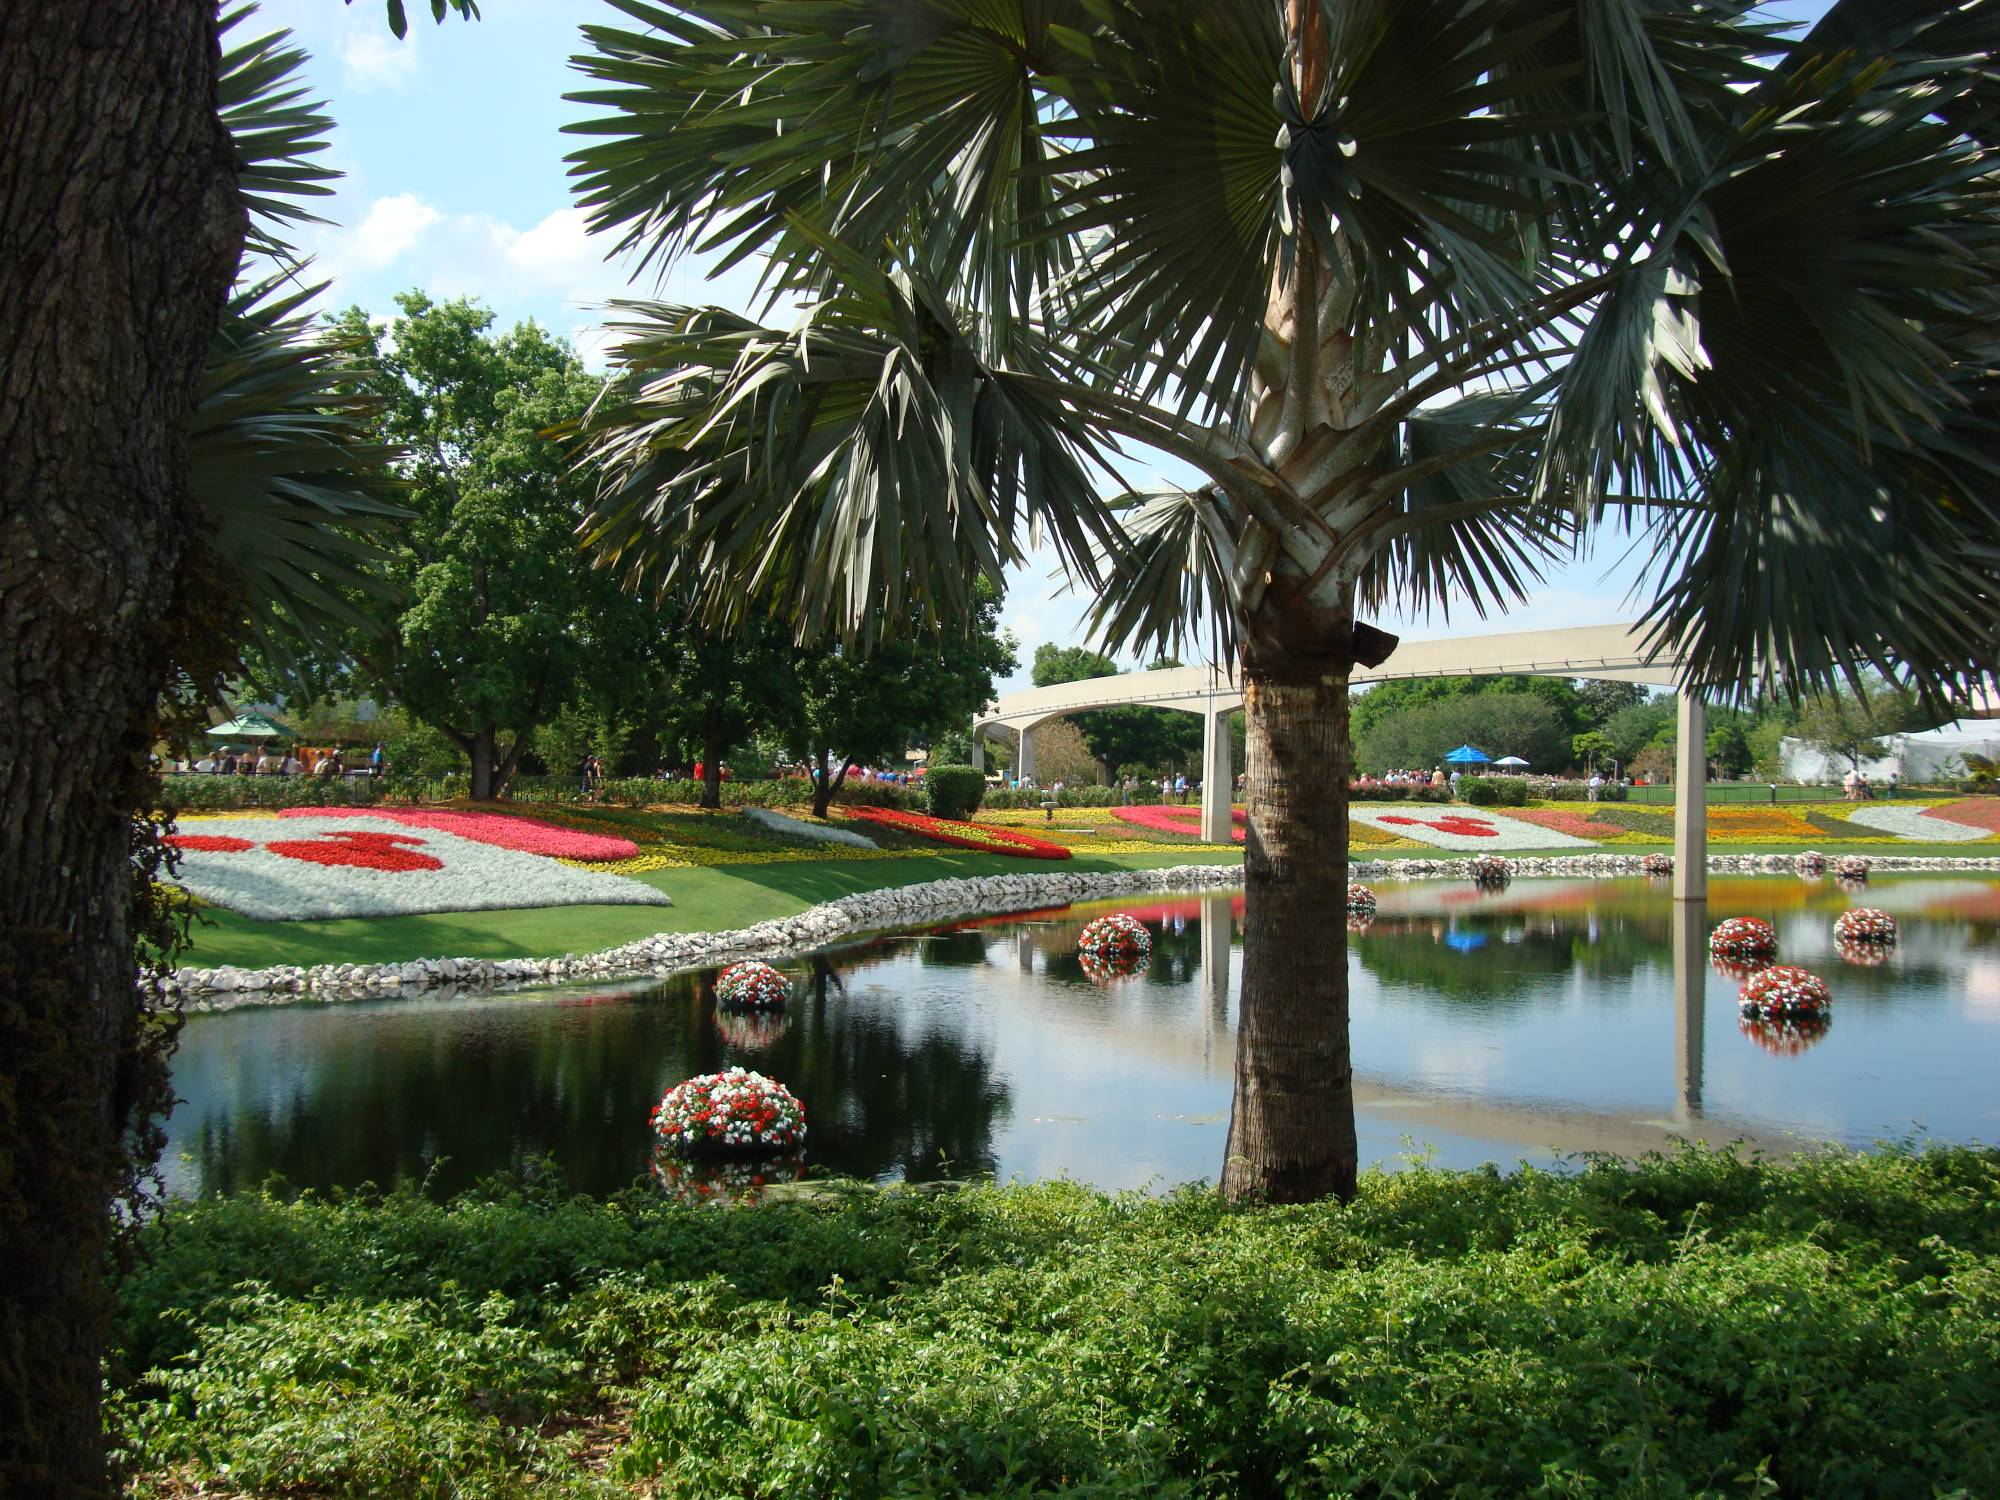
(1222, 656, 1358, 1202)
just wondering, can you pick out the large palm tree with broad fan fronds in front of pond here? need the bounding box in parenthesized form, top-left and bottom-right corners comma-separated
(570, 0, 2000, 1200)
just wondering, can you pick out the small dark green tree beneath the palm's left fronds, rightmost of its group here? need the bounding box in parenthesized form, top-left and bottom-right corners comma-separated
(800, 584, 1014, 818)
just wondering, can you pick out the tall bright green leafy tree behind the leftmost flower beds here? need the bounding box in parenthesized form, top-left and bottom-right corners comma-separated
(338, 292, 626, 800)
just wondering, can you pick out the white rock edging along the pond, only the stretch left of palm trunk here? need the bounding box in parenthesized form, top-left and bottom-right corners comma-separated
(162, 864, 1244, 1010)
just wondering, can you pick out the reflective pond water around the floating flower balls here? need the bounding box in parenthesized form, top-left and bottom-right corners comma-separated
(164, 874, 2000, 1192)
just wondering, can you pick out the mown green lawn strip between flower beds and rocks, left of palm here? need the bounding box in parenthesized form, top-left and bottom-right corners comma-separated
(180, 850, 1242, 968)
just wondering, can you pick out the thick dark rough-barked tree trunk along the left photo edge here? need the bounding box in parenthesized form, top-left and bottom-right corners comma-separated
(0, 0, 244, 1498)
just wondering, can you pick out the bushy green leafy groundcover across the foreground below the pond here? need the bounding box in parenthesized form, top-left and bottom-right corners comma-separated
(110, 1148, 2000, 1496)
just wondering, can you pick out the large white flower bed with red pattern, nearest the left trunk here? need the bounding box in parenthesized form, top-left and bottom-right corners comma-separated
(164, 816, 674, 922)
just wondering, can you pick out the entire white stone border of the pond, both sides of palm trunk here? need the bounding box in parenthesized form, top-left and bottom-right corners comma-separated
(166, 854, 2000, 1010)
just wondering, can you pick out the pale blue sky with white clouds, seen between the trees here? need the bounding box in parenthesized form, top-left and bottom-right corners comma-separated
(258, 0, 1828, 682)
